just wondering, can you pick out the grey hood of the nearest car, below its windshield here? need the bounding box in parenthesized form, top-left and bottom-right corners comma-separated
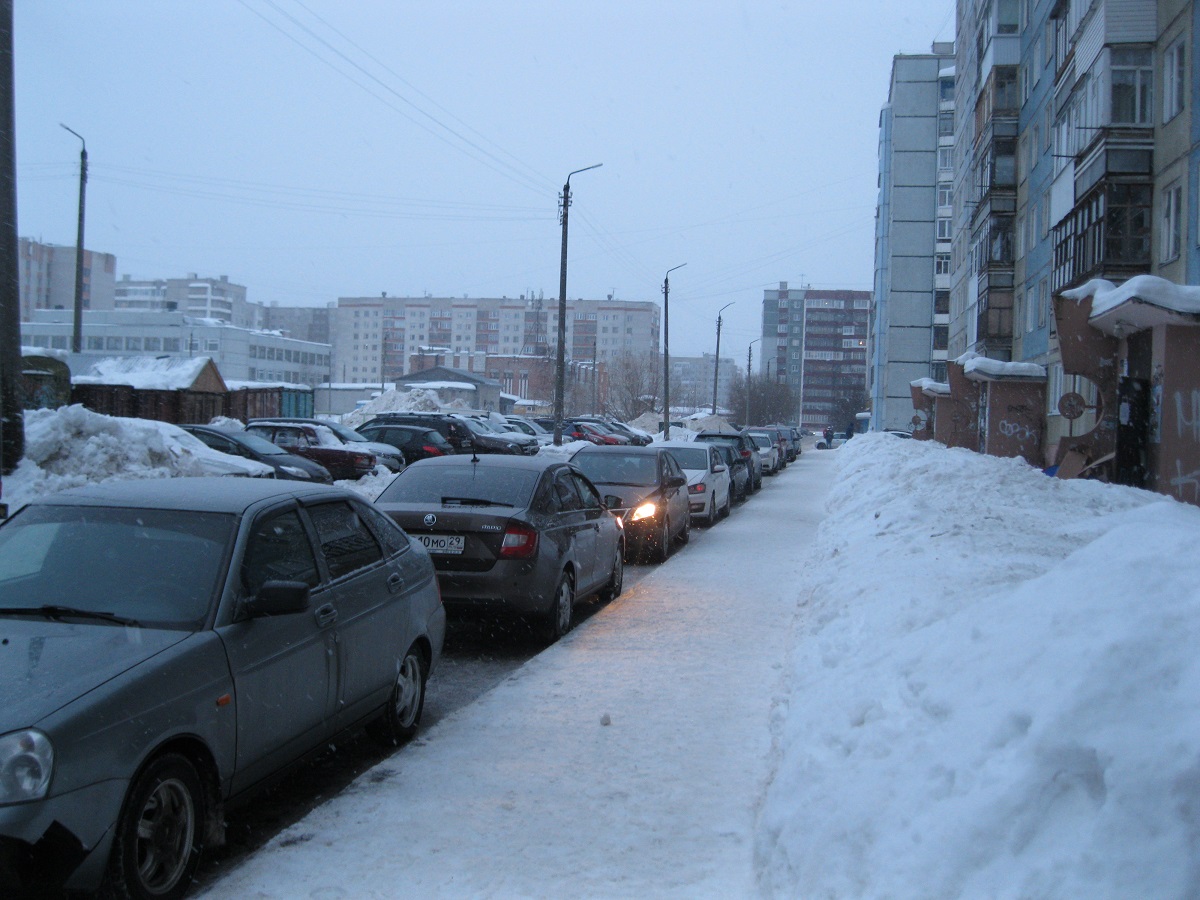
(0, 617, 191, 734)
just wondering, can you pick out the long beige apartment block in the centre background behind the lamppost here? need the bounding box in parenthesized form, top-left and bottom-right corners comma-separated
(330, 294, 659, 398)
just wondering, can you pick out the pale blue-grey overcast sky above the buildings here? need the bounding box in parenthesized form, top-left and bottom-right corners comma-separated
(16, 0, 954, 361)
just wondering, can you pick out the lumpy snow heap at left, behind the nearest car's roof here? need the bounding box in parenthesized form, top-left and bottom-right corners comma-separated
(4, 404, 271, 512)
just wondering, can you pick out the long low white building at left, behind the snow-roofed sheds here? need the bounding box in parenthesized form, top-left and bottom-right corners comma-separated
(20, 310, 330, 386)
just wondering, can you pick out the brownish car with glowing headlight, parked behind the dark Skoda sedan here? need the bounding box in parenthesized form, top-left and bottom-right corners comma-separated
(571, 444, 691, 563)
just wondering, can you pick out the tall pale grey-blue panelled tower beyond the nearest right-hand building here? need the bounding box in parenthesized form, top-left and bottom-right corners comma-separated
(869, 43, 954, 428)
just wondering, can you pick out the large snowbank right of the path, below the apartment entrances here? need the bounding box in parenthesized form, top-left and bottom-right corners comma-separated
(758, 434, 1200, 898)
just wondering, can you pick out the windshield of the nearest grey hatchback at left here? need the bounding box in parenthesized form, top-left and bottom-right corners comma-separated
(0, 505, 236, 630)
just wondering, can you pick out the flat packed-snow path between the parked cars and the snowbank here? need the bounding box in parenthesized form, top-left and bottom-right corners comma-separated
(206, 451, 835, 898)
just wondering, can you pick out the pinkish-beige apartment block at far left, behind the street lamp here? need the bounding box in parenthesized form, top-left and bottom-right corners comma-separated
(17, 238, 116, 320)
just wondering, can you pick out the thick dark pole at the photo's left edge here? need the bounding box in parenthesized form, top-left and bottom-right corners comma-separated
(0, 0, 25, 494)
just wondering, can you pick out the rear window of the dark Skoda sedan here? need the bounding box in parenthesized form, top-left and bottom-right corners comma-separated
(377, 463, 540, 508)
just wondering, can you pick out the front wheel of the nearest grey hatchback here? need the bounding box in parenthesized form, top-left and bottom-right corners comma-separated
(107, 754, 208, 900)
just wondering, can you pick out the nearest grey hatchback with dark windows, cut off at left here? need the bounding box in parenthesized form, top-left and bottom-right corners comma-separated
(0, 478, 445, 898)
